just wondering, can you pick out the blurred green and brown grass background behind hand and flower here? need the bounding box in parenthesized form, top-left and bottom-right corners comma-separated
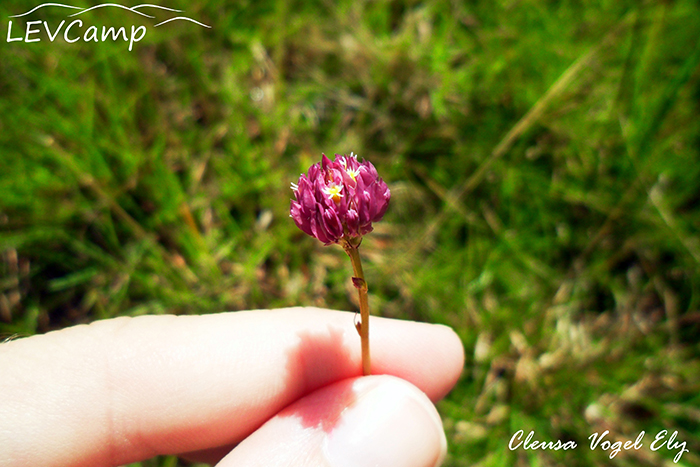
(0, 0, 700, 466)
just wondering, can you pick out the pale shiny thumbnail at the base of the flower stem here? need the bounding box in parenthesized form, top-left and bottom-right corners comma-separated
(325, 376, 447, 467)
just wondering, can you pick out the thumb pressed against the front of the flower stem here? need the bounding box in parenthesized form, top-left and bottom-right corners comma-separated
(218, 376, 447, 467)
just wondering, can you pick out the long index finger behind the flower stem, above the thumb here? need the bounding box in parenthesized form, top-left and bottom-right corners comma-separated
(0, 308, 463, 466)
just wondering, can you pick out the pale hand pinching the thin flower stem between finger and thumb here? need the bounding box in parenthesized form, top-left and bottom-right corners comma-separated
(0, 308, 464, 467)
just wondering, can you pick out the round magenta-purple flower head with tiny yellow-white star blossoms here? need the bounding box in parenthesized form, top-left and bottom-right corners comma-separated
(290, 153, 391, 245)
